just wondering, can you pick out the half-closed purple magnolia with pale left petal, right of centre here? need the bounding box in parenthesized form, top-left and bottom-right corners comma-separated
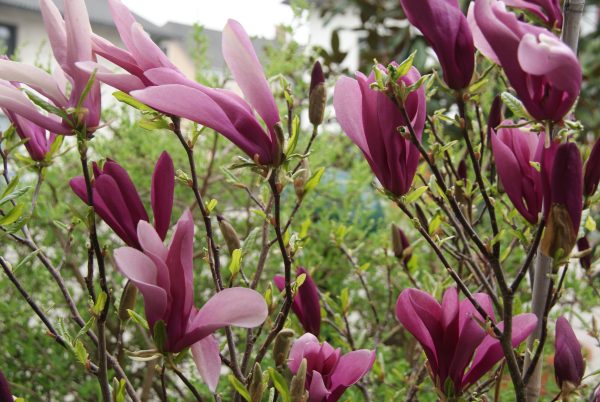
(333, 66, 426, 196)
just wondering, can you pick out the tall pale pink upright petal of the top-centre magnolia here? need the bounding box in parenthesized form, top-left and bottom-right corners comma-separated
(222, 20, 280, 130)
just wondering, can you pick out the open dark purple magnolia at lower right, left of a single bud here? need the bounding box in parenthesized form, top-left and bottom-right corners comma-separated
(396, 288, 537, 397)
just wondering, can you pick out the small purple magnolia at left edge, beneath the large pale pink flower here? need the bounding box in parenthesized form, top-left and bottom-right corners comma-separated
(0, 80, 56, 162)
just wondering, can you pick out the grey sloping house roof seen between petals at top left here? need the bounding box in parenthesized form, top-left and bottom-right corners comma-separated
(0, 0, 165, 38)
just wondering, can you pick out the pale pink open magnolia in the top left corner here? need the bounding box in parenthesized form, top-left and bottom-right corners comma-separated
(0, 0, 100, 134)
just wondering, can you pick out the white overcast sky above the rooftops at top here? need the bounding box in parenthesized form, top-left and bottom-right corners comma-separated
(123, 0, 300, 38)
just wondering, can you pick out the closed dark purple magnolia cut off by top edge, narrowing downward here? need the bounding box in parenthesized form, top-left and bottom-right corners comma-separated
(400, 0, 475, 89)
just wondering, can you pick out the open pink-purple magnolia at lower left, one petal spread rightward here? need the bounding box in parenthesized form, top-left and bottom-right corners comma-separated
(114, 210, 267, 392)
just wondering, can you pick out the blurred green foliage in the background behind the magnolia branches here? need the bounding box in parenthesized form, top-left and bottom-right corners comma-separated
(0, 0, 600, 401)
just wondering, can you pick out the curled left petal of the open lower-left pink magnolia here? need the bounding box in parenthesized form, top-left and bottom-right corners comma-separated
(114, 247, 167, 328)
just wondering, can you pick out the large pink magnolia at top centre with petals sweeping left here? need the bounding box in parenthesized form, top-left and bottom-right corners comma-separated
(131, 20, 282, 165)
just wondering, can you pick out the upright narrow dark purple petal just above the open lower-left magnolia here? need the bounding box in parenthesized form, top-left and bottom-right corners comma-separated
(151, 151, 175, 240)
